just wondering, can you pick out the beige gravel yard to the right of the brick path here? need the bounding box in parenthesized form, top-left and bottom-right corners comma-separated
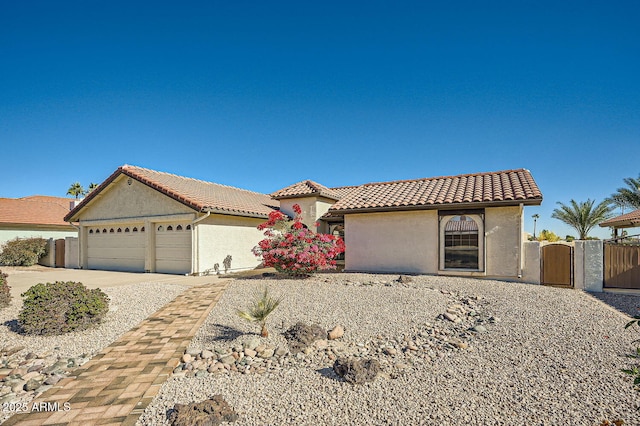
(138, 274, 640, 425)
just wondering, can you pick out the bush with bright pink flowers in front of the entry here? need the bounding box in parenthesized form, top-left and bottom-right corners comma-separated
(253, 204, 344, 276)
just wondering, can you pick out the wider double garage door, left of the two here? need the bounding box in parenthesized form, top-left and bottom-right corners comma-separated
(87, 225, 145, 272)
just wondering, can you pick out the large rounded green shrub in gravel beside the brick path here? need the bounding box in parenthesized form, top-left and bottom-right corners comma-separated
(18, 281, 109, 335)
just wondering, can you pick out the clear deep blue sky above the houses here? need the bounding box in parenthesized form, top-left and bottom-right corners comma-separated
(0, 0, 640, 237)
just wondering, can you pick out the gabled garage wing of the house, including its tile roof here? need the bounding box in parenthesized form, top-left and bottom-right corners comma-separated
(65, 165, 274, 274)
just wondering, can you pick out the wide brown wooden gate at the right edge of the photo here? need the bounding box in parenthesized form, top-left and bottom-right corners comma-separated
(604, 243, 640, 289)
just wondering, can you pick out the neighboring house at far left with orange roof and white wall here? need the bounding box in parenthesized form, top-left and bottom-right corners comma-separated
(0, 195, 78, 246)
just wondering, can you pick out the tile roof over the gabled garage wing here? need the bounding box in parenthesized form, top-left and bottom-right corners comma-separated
(66, 165, 276, 220)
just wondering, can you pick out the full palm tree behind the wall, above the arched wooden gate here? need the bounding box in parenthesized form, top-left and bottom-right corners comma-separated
(551, 199, 613, 240)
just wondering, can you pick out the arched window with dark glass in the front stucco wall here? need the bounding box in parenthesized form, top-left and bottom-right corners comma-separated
(444, 215, 480, 270)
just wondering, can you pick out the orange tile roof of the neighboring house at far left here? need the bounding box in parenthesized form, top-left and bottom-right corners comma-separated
(0, 195, 75, 229)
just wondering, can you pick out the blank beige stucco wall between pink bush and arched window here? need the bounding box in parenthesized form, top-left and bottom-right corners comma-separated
(345, 210, 438, 274)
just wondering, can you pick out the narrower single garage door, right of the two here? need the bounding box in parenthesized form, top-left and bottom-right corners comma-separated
(155, 222, 191, 274)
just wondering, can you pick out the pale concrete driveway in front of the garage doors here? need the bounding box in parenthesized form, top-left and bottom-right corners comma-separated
(0, 266, 221, 298)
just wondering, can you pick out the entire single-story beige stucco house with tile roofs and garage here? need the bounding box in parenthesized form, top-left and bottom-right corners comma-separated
(65, 165, 542, 279)
